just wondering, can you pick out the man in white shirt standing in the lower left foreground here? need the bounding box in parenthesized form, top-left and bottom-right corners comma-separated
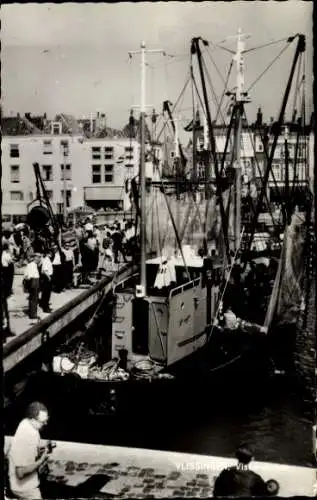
(8, 401, 48, 500)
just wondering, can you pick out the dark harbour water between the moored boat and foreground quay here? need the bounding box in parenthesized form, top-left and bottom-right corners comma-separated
(5, 366, 312, 467)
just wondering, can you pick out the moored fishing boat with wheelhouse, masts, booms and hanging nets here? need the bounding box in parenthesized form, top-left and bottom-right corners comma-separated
(34, 31, 305, 414)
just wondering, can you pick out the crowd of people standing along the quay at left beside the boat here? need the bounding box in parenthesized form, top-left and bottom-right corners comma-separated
(1, 219, 137, 340)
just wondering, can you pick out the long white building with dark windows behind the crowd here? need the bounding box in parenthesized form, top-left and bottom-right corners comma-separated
(2, 130, 140, 216)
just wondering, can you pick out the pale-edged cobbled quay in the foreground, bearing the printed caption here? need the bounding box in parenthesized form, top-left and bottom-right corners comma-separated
(5, 437, 316, 498)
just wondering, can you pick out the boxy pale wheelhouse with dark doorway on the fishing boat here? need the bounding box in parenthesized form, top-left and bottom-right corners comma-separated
(112, 249, 222, 366)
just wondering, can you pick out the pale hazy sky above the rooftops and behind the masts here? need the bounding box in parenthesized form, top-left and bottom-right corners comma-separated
(1, 0, 313, 128)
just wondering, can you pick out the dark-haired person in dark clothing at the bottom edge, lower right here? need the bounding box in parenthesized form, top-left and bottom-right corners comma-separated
(213, 447, 268, 498)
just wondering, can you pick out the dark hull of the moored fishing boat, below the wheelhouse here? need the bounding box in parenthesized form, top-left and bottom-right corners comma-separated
(25, 331, 272, 418)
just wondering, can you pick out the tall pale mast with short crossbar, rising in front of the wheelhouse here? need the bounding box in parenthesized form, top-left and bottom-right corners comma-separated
(129, 42, 164, 297)
